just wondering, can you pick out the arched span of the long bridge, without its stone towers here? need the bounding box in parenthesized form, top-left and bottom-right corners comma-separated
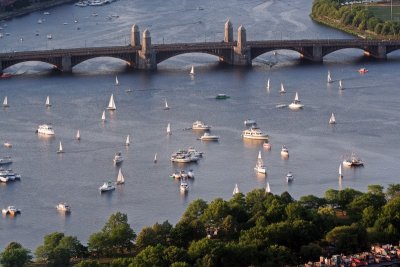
(0, 39, 400, 73)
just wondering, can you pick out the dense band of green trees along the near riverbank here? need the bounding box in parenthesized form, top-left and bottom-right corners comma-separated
(0, 184, 400, 267)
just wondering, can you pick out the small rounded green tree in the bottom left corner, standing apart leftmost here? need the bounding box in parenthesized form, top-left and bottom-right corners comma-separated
(0, 242, 32, 267)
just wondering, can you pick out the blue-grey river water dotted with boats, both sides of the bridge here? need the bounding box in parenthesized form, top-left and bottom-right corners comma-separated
(0, 0, 400, 249)
